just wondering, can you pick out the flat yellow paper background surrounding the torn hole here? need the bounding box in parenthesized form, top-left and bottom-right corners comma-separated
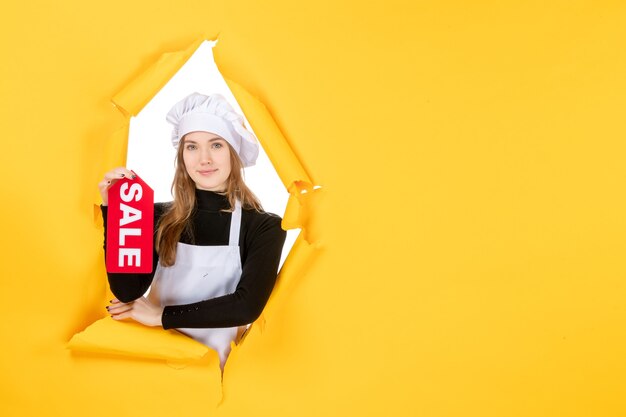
(0, 0, 626, 417)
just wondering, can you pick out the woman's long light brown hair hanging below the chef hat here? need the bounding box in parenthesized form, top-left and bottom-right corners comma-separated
(156, 137, 263, 266)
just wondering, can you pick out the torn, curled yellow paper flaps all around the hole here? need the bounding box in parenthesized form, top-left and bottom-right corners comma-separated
(77, 39, 320, 374)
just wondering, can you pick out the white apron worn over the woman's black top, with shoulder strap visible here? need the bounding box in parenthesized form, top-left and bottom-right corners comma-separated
(148, 201, 241, 369)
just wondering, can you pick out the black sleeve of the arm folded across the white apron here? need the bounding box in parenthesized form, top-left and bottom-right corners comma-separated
(162, 214, 287, 329)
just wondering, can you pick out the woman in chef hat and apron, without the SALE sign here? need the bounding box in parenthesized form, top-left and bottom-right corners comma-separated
(99, 93, 286, 369)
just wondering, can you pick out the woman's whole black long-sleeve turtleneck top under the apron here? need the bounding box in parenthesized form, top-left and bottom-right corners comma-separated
(101, 190, 287, 329)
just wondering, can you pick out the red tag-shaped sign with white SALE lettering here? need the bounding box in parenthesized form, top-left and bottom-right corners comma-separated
(106, 172, 154, 273)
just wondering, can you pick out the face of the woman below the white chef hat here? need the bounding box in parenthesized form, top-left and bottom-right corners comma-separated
(182, 132, 230, 191)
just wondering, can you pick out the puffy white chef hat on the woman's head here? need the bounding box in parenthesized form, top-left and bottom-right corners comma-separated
(166, 93, 259, 167)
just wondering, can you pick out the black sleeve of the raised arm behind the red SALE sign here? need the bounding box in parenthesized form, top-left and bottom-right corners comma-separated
(100, 204, 163, 303)
